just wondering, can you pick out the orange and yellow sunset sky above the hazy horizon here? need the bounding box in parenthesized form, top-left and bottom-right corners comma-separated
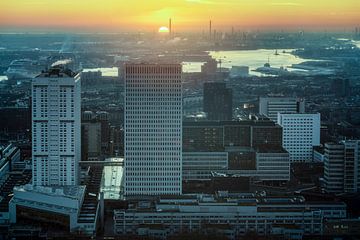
(0, 0, 360, 31)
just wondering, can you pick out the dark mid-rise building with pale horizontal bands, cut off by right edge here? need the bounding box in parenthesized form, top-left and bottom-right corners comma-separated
(324, 140, 360, 193)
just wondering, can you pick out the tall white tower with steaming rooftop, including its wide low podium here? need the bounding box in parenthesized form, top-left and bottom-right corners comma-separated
(9, 66, 103, 235)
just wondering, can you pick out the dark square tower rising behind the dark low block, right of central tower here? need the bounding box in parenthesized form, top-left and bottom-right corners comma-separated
(204, 82, 232, 121)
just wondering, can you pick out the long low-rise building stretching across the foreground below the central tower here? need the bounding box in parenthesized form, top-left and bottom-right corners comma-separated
(114, 194, 346, 239)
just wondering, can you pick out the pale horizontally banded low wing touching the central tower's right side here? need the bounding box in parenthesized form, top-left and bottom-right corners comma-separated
(182, 152, 228, 180)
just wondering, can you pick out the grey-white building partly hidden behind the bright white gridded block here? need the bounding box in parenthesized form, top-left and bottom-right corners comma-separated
(259, 97, 305, 122)
